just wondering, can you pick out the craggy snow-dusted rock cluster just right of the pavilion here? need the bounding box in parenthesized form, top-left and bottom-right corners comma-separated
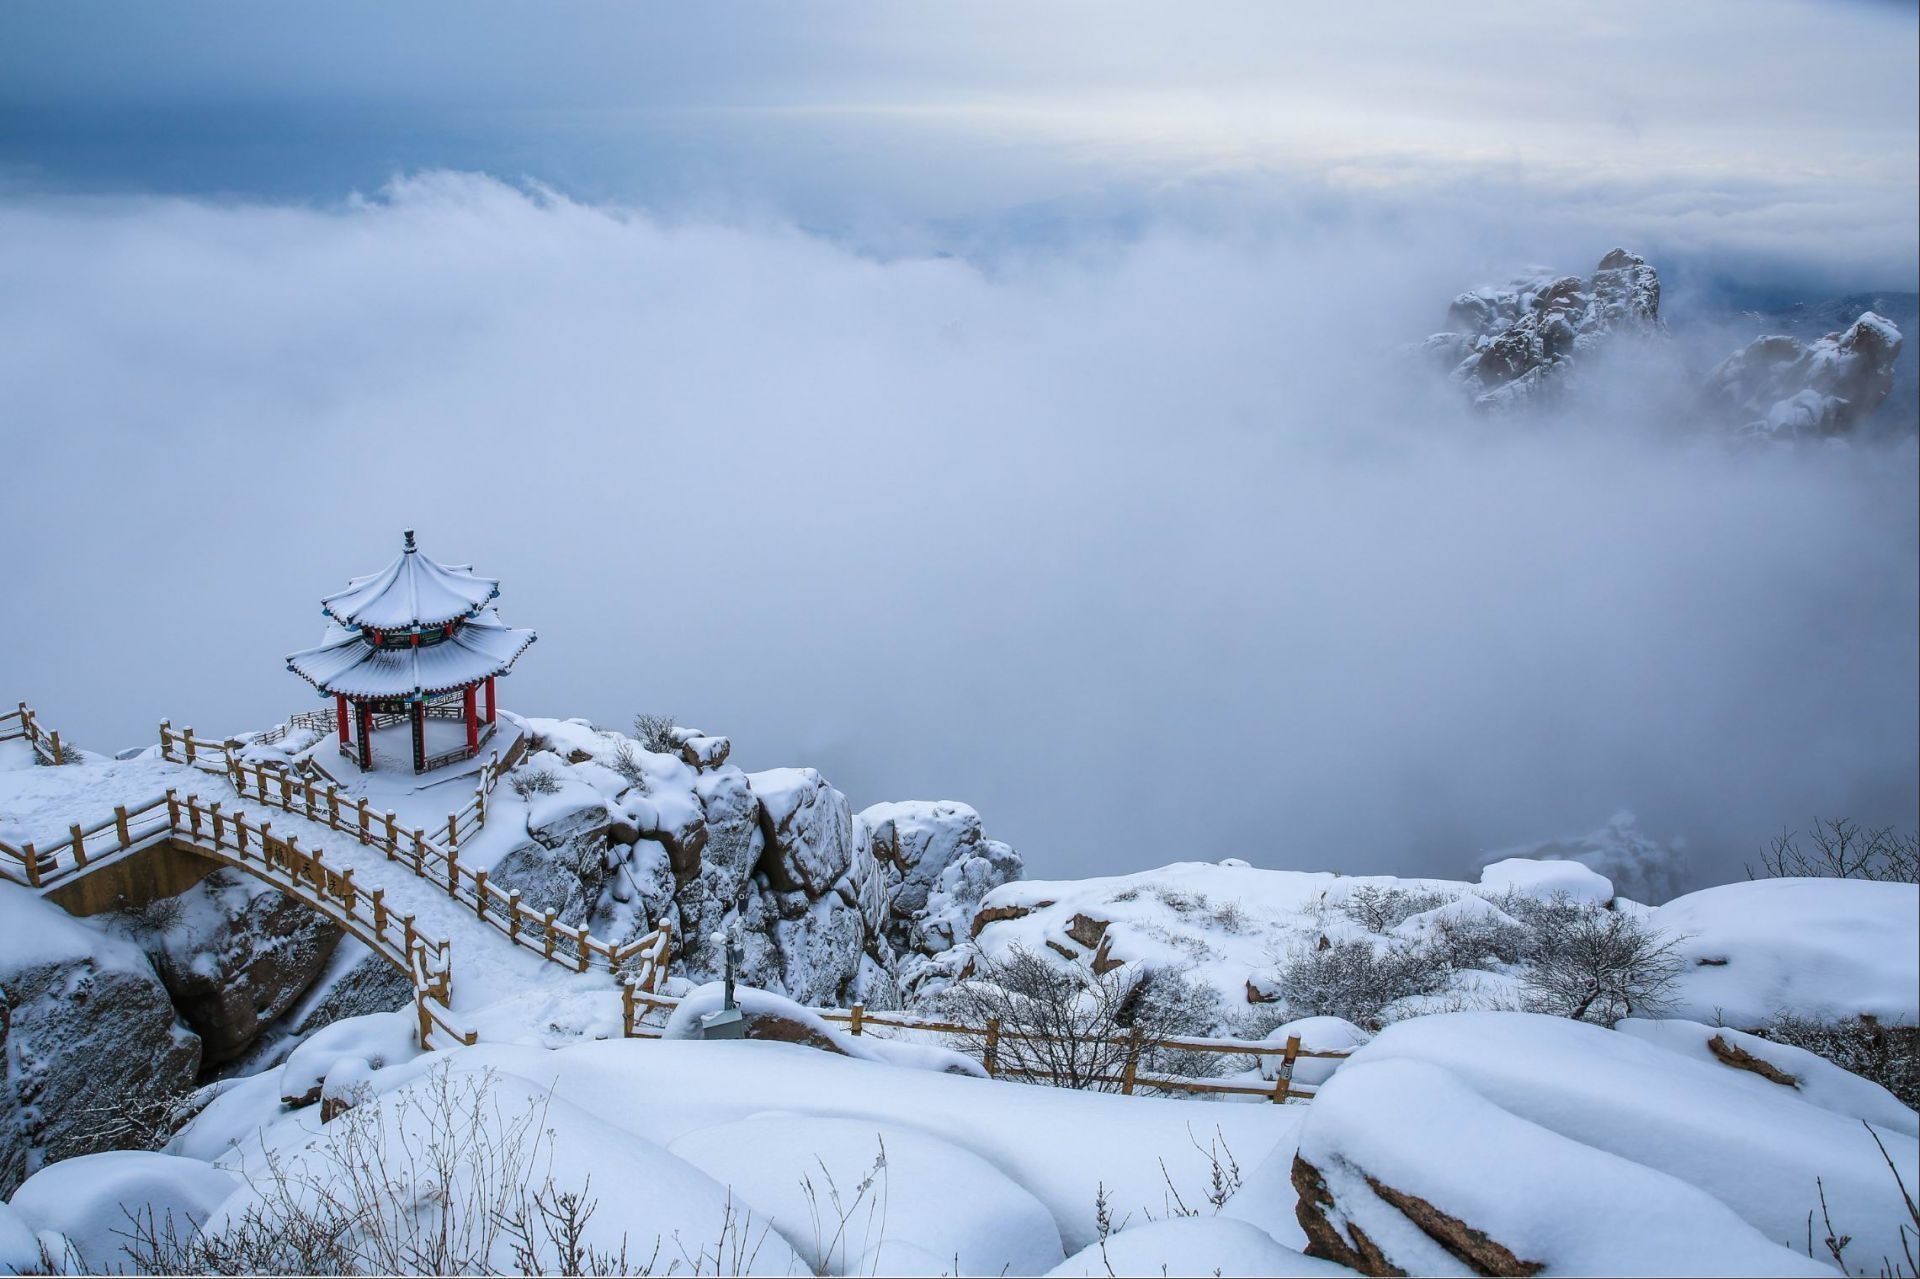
(492, 720, 1020, 1006)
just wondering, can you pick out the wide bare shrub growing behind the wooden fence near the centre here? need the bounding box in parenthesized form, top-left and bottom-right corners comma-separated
(935, 945, 1219, 1093)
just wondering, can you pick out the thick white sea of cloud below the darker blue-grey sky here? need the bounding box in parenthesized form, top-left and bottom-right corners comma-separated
(0, 175, 1920, 878)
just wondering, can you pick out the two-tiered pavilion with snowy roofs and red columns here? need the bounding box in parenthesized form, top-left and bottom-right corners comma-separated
(286, 528, 536, 772)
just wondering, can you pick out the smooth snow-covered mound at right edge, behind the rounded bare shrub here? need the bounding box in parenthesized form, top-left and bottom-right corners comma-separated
(1651, 880, 1920, 1027)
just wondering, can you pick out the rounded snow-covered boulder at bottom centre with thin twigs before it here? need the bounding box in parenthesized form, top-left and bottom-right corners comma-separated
(666, 1114, 1062, 1275)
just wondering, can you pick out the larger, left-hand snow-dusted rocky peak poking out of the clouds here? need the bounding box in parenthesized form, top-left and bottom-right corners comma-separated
(1423, 250, 1663, 409)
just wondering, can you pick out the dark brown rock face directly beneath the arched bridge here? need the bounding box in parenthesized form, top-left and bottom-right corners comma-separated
(144, 870, 344, 1066)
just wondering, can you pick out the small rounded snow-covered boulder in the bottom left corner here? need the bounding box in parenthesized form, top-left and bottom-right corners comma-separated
(10, 1150, 240, 1275)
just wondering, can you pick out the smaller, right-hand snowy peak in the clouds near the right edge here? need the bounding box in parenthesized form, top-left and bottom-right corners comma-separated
(1705, 311, 1901, 440)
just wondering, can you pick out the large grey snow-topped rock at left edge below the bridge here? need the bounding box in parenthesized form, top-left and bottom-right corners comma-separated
(0, 883, 200, 1195)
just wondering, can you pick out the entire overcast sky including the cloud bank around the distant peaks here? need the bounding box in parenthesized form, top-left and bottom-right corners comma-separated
(0, 0, 1920, 894)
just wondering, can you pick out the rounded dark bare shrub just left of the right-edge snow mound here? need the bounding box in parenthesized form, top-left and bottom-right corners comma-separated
(1511, 893, 1682, 1026)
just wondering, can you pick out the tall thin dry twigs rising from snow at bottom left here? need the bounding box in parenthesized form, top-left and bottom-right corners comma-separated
(127, 1066, 766, 1275)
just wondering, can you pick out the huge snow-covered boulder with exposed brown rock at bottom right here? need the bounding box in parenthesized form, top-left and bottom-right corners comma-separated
(1292, 1012, 1920, 1275)
